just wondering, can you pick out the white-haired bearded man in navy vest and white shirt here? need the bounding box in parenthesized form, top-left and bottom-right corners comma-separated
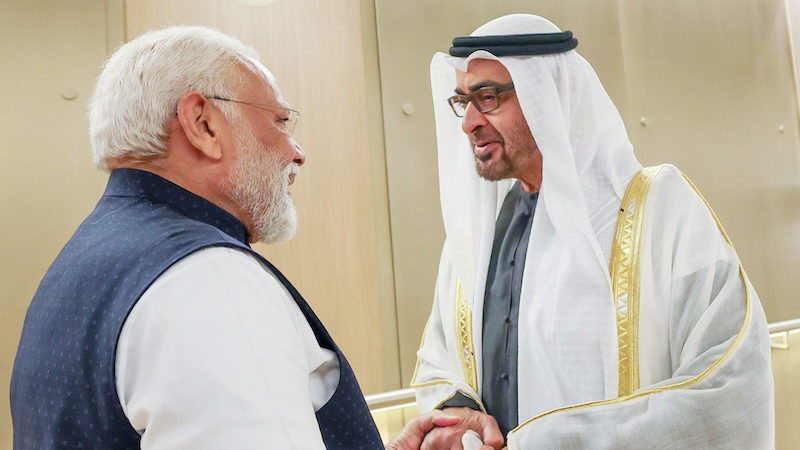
(11, 27, 457, 449)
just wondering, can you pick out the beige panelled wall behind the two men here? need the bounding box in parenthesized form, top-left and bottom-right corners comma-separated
(0, 0, 800, 448)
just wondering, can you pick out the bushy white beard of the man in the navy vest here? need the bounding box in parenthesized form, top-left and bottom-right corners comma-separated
(226, 123, 299, 244)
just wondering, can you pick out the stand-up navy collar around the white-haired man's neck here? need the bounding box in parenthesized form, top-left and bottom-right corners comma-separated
(103, 169, 248, 245)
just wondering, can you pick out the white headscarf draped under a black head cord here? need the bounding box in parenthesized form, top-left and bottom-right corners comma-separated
(431, 14, 641, 417)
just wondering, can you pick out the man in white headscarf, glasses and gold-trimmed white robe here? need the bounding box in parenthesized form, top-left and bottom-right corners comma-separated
(412, 14, 774, 448)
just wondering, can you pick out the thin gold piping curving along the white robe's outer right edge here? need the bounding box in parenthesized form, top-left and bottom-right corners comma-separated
(509, 169, 752, 433)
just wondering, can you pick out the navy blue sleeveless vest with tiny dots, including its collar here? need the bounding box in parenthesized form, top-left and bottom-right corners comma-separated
(11, 169, 383, 450)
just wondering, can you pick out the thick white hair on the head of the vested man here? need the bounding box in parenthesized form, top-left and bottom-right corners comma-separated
(89, 26, 271, 170)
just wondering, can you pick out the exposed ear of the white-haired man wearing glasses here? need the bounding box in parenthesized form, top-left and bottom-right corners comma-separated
(176, 91, 227, 161)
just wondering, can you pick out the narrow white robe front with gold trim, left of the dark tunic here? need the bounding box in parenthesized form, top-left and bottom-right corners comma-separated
(411, 242, 485, 412)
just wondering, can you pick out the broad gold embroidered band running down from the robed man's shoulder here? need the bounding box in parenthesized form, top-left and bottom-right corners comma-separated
(609, 166, 661, 397)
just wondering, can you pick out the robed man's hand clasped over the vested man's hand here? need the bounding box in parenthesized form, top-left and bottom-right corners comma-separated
(420, 408, 505, 450)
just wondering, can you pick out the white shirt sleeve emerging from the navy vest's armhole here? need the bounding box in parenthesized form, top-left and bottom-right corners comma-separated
(116, 248, 326, 449)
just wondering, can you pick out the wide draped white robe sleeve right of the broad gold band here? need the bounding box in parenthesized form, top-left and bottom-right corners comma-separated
(508, 168, 774, 449)
